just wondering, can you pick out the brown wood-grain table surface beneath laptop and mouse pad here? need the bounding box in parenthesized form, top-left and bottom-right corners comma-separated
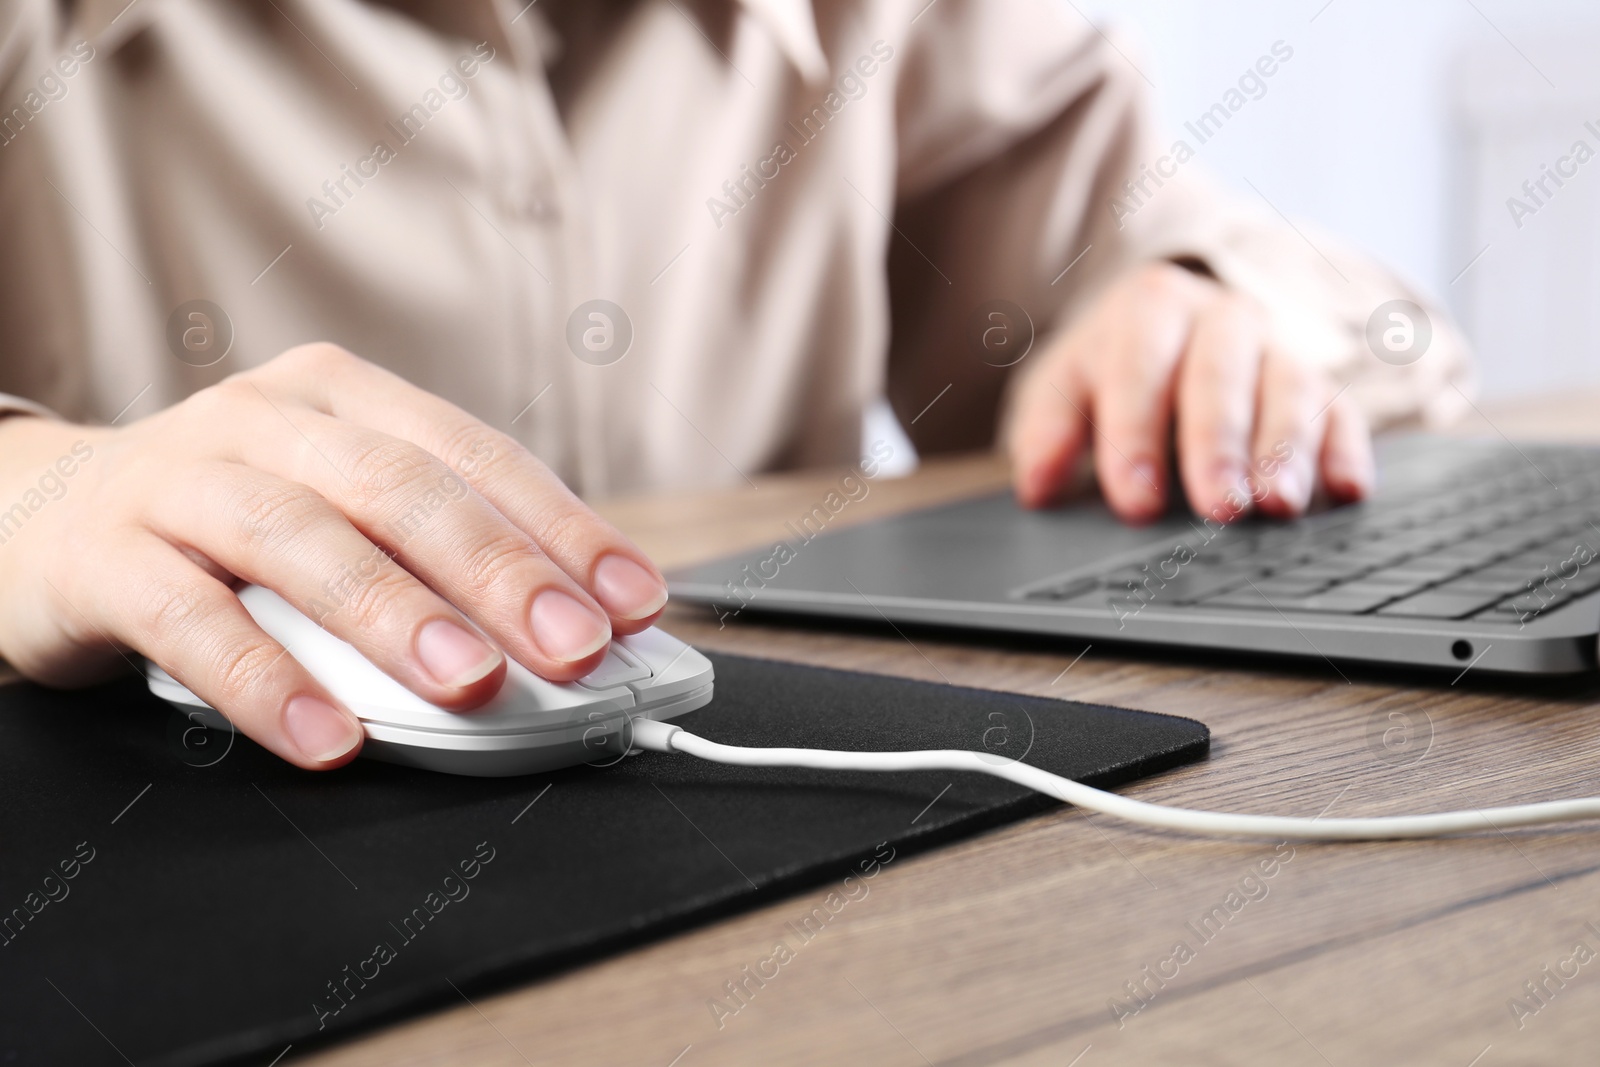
(304, 397, 1600, 1067)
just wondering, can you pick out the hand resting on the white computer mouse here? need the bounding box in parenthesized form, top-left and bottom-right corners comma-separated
(0, 344, 667, 768)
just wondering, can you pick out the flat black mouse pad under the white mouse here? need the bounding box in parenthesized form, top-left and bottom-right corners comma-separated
(0, 656, 1210, 1067)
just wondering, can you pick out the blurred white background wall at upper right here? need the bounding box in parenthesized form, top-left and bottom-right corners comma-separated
(1062, 0, 1600, 398)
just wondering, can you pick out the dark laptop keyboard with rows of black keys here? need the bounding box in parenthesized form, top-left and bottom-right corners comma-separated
(1022, 446, 1600, 625)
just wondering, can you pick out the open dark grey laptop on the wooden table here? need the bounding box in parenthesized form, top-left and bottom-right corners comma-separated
(667, 435, 1600, 673)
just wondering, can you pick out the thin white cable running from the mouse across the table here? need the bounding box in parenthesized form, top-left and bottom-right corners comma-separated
(620, 718, 1600, 841)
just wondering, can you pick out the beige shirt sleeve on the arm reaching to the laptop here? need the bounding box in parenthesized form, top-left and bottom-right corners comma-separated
(890, 0, 1472, 451)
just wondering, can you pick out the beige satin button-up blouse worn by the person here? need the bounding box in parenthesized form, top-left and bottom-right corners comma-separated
(0, 0, 1466, 494)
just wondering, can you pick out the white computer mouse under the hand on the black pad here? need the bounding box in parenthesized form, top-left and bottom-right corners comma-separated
(146, 585, 712, 777)
